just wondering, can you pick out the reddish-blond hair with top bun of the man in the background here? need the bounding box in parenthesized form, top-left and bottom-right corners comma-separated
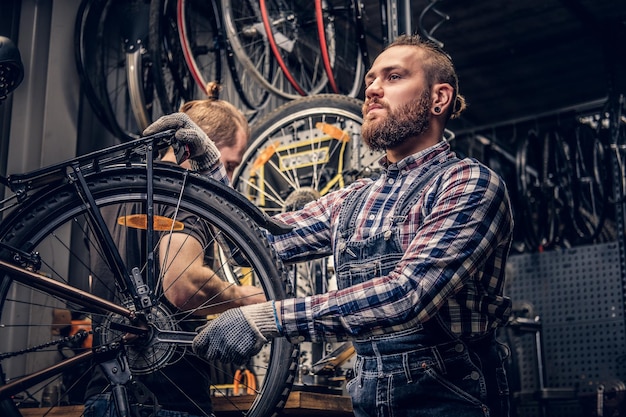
(180, 82, 250, 148)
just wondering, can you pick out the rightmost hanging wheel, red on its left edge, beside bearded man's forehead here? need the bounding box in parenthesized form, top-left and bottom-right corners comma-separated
(315, 0, 369, 97)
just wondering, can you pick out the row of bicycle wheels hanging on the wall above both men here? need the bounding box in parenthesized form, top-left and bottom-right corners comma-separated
(75, 0, 367, 141)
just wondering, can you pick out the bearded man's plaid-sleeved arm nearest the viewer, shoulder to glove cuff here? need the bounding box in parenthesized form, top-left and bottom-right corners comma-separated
(277, 159, 513, 341)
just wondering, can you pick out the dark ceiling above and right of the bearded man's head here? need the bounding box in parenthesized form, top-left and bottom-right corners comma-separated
(356, 0, 626, 130)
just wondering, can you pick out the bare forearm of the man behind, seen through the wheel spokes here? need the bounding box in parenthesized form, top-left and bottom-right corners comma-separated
(159, 233, 265, 315)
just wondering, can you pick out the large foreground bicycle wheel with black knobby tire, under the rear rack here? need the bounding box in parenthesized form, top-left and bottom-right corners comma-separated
(0, 165, 296, 417)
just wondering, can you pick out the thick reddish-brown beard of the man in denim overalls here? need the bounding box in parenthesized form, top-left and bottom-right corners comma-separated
(361, 91, 431, 151)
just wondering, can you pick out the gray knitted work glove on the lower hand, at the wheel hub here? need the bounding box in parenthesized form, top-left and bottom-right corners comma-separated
(191, 301, 280, 365)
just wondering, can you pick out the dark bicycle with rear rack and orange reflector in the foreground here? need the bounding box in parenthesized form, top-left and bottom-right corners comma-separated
(0, 132, 297, 417)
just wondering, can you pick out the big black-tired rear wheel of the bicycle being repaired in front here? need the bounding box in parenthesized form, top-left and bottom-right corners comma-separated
(0, 165, 296, 417)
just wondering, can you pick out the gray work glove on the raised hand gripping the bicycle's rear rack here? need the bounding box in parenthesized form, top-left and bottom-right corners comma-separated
(143, 113, 220, 172)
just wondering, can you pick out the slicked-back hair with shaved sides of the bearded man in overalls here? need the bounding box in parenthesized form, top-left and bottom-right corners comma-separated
(385, 35, 467, 119)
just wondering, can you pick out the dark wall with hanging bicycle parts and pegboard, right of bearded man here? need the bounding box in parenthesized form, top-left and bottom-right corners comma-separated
(454, 97, 626, 417)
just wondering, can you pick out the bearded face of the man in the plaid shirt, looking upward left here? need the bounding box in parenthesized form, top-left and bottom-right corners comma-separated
(361, 46, 431, 150)
